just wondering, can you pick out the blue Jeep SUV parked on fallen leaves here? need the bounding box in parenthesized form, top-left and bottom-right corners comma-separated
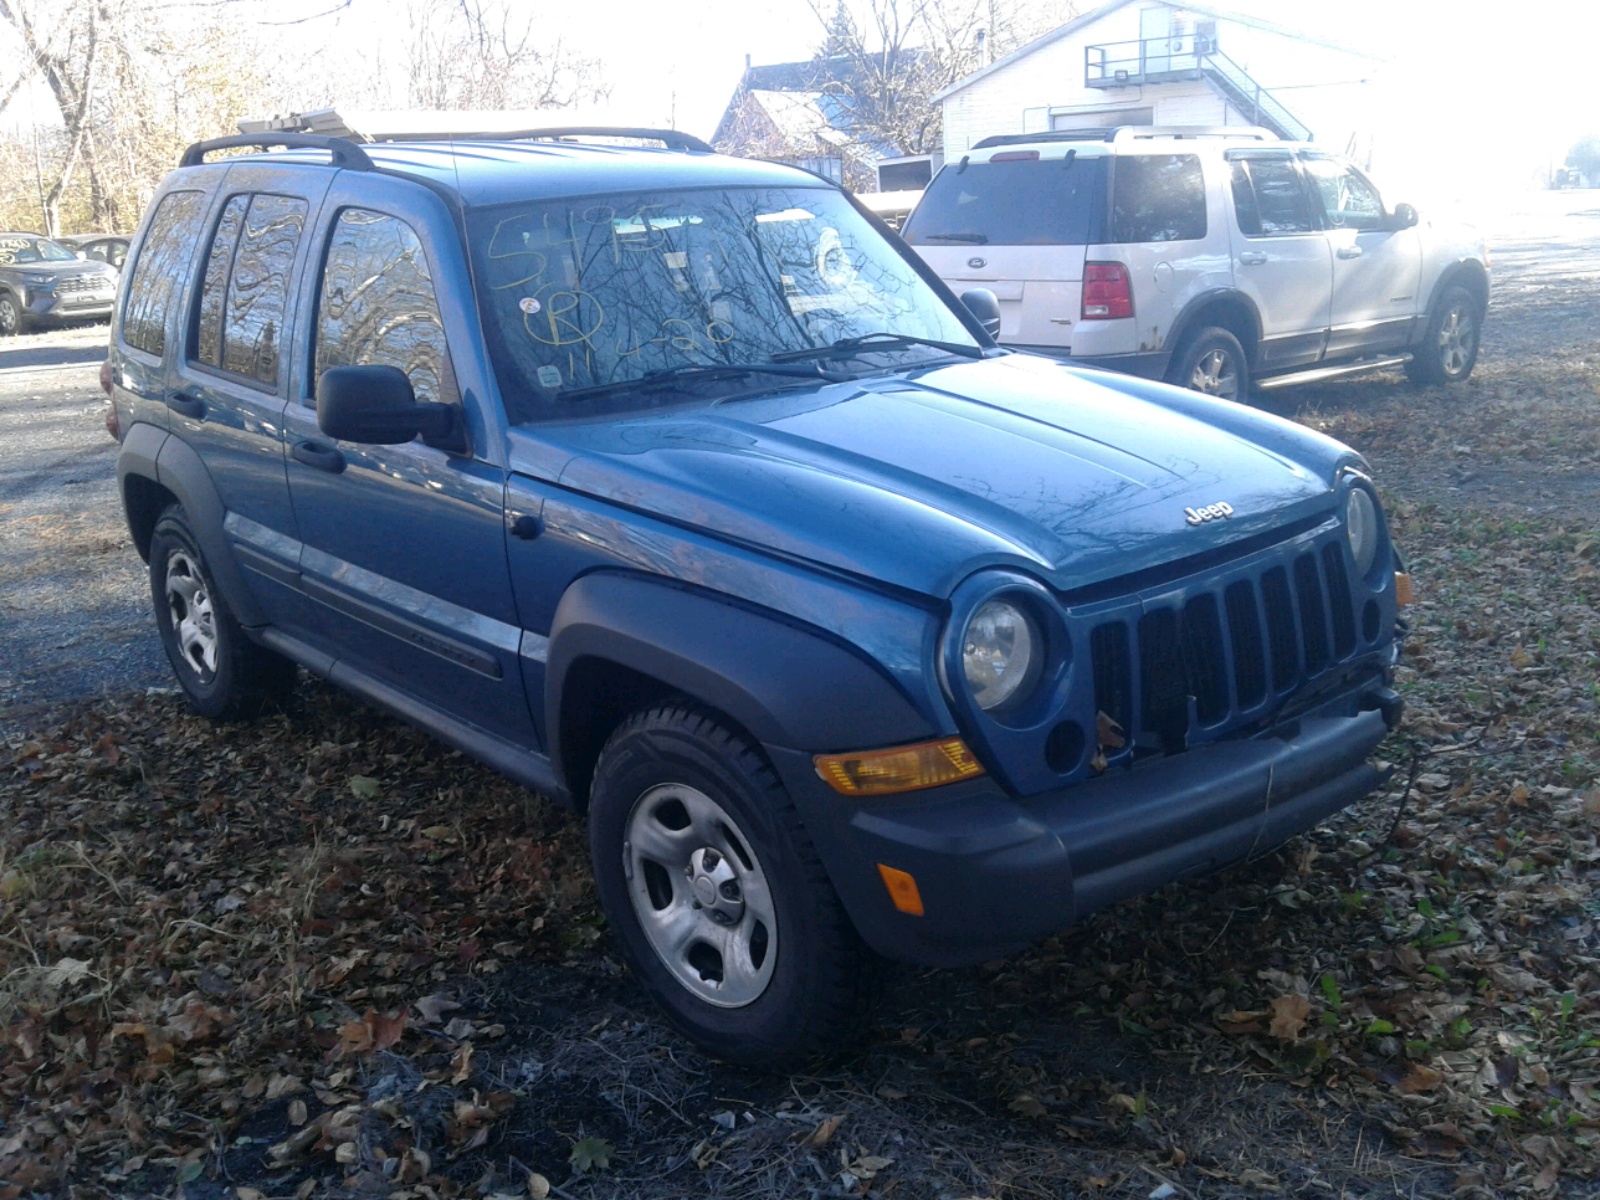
(104, 128, 1406, 1066)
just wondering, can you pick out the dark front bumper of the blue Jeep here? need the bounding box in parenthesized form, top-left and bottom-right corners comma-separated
(768, 686, 1400, 966)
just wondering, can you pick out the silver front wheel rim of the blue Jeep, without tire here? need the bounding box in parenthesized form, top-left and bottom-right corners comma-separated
(622, 784, 778, 1008)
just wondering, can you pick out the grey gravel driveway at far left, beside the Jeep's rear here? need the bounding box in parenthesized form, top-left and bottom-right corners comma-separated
(0, 323, 171, 730)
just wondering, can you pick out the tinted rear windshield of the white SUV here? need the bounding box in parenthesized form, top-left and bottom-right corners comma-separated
(904, 157, 1113, 246)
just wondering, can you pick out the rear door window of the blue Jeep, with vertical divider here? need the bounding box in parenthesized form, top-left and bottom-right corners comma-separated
(195, 194, 307, 387)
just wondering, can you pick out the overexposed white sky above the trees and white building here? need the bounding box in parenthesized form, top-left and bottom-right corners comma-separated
(275, 0, 1600, 206)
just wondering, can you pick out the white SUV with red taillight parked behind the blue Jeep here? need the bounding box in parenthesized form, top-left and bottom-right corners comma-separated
(904, 126, 1490, 400)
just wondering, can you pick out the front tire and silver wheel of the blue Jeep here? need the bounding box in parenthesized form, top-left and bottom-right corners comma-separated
(589, 701, 878, 1070)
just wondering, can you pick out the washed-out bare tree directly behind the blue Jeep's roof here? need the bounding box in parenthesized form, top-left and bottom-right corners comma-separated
(408, 0, 608, 109)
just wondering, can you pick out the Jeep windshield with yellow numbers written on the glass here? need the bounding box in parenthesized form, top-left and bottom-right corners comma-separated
(467, 187, 976, 421)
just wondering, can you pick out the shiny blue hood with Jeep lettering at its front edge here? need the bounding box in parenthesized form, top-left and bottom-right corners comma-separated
(510, 355, 1355, 598)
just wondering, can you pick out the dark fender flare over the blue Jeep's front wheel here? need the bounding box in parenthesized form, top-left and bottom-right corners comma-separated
(544, 571, 938, 790)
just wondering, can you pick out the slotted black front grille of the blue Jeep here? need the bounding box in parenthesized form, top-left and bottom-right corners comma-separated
(1090, 541, 1357, 754)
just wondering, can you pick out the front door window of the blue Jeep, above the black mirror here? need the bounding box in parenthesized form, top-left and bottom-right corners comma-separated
(314, 208, 454, 403)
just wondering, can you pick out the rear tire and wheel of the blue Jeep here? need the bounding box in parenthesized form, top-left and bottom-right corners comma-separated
(150, 504, 294, 722)
